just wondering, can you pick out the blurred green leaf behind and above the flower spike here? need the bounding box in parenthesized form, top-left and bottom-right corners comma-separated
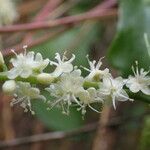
(30, 22, 100, 71)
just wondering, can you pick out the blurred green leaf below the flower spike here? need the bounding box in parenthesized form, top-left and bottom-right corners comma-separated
(32, 100, 83, 130)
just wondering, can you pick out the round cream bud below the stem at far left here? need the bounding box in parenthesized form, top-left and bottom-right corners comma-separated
(2, 80, 16, 94)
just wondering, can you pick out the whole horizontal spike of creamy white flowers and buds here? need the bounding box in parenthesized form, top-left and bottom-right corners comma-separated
(0, 47, 150, 115)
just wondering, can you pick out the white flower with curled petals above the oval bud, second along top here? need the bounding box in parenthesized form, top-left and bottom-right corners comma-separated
(50, 53, 75, 77)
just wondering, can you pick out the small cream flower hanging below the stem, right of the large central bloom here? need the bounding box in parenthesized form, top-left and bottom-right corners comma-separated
(78, 87, 103, 115)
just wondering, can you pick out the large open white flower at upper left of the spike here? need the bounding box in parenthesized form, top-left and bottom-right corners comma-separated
(8, 47, 49, 79)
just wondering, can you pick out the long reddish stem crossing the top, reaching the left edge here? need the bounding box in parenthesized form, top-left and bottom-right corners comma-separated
(0, 9, 117, 33)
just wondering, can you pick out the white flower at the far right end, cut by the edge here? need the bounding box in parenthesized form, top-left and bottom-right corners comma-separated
(126, 66, 150, 95)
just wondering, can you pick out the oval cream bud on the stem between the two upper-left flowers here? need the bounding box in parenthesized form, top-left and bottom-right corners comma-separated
(37, 73, 55, 84)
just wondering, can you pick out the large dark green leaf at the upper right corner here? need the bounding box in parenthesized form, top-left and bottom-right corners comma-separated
(108, 0, 150, 76)
